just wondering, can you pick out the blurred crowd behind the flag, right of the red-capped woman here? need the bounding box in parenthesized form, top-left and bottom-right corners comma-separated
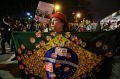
(69, 20, 120, 32)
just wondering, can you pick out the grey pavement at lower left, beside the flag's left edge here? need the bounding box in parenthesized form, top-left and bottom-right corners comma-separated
(0, 41, 20, 79)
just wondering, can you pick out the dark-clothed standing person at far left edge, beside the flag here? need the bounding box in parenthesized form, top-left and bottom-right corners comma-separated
(0, 17, 12, 54)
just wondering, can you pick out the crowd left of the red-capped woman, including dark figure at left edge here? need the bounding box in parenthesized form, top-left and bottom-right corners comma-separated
(0, 17, 50, 54)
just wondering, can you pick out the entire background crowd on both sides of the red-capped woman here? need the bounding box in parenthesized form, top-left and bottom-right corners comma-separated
(0, 13, 120, 54)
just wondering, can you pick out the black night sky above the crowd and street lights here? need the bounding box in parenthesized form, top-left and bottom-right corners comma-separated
(0, 0, 120, 21)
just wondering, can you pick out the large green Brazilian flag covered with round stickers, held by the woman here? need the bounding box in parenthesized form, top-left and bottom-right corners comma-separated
(13, 30, 120, 79)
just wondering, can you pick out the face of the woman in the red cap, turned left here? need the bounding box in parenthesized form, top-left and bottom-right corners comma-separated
(51, 18, 64, 33)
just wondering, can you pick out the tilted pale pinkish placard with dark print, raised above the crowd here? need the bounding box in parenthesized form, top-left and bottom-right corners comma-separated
(35, 1, 54, 22)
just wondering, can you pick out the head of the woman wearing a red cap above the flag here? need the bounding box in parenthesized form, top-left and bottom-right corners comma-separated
(50, 12, 69, 33)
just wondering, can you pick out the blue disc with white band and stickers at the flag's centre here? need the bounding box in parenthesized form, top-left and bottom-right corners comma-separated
(44, 47, 78, 79)
